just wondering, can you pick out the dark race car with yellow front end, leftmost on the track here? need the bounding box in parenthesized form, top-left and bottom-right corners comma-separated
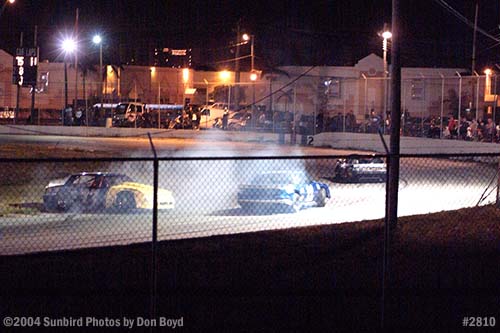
(43, 172, 175, 211)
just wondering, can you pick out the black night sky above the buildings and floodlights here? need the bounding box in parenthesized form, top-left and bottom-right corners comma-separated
(0, 0, 500, 68)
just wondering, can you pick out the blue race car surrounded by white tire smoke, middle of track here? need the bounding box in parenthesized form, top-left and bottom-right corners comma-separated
(238, 170, 330, 212)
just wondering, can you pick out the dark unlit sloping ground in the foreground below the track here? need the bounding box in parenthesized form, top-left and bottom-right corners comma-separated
(0, 207, 500, 332)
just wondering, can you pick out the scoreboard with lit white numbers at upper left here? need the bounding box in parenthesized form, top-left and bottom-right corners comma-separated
(12, 47, 38, 87)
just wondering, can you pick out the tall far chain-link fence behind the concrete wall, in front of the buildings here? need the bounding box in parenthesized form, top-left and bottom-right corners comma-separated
(0, 72, 500, 141)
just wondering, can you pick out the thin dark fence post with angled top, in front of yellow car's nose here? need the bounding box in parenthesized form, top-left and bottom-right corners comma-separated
(148, 132, 159, 331)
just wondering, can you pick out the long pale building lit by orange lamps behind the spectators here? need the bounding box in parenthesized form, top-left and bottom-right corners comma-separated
(0, 50, 498, 126)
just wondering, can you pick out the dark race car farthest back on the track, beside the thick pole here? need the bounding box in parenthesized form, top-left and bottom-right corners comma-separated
(335, 157, 387, 182)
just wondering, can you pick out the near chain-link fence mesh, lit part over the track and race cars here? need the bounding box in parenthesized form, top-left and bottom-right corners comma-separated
(0, 155, 498, 255)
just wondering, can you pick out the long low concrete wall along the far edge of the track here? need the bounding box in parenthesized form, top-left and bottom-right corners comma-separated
(0, 125, 500, 154)
